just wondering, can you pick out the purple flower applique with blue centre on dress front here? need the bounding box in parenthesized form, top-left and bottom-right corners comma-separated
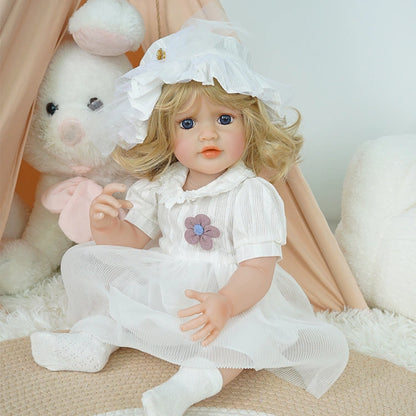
(185, 214, 220, 250)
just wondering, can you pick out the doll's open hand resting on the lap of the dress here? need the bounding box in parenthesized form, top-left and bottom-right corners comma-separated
(178, 290, 233, 346)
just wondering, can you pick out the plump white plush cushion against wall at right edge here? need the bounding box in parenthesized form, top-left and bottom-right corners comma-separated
(335, 135, 416, 320)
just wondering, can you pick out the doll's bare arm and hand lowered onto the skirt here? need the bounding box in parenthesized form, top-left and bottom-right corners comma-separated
(178, 257, 277, 346)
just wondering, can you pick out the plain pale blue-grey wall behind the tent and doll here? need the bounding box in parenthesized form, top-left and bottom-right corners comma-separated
(221, 0, 416, 227)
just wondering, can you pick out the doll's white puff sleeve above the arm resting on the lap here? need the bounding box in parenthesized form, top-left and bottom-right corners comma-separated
(233, 178, 286, 263)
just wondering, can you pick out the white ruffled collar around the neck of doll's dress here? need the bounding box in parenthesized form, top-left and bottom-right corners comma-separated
(158, 162, 256, 208)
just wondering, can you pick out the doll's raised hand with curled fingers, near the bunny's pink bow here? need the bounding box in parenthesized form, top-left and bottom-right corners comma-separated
(90, 183, 133, 230)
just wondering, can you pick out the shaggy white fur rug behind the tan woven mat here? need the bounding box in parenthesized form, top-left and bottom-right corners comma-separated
(0, 275, 416, 372)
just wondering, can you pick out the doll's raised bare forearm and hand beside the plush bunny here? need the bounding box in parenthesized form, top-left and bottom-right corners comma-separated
(90, 183, 150, 248)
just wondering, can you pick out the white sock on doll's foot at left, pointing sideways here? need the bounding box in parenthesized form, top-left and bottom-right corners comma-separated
(30, 332, 118, 373)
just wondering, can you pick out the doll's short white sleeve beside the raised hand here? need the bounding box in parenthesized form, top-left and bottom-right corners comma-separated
(125, 179, 160, 239)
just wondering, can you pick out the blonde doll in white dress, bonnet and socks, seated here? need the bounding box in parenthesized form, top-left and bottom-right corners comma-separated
(31, 22, 348, 416)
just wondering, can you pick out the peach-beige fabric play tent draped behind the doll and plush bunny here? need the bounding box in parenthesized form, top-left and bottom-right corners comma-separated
(0, 0, 367, 310)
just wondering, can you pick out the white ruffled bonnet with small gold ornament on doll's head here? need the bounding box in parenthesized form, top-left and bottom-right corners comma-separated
(96, 19, 287, 154)
